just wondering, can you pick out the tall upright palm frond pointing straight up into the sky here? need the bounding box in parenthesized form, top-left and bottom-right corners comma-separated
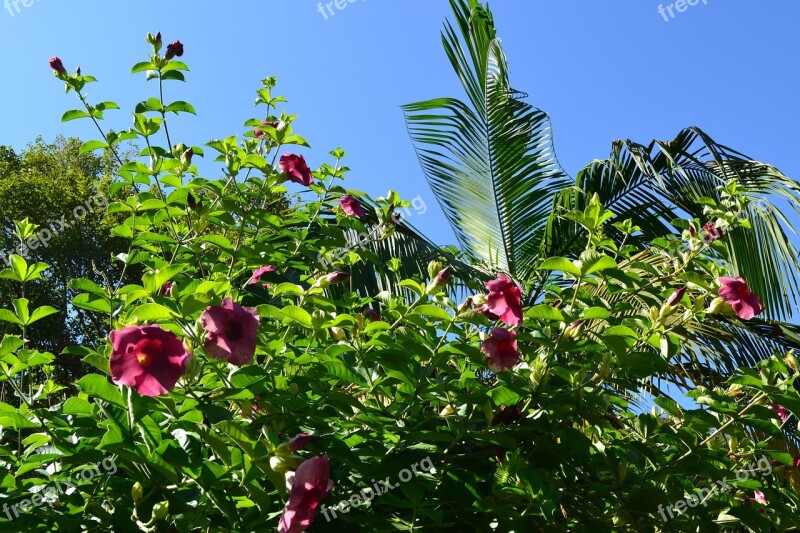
(403, 0, 570, 278)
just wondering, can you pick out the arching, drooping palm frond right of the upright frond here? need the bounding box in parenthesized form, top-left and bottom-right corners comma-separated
(572, 128, 800, 319)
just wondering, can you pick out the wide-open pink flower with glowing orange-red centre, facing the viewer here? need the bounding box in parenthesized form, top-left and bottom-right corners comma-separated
(109, 326, 190, 396)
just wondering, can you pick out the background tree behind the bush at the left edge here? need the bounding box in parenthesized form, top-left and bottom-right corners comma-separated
(0, 137, 125, 383)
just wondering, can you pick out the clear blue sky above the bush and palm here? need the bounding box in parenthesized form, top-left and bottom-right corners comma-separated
(0, 0, 800, 247)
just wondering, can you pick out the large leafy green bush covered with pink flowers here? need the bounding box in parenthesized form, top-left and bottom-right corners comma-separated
(0, 35, 800, 532)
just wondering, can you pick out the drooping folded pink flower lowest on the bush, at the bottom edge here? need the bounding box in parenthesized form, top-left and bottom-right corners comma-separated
(278, 455, 333, 533)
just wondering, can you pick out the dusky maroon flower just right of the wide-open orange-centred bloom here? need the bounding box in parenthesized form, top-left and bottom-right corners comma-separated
(200, 298, 260, 366)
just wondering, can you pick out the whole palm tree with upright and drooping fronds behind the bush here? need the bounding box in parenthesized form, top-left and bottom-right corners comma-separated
(404, 0, 800, 384)
